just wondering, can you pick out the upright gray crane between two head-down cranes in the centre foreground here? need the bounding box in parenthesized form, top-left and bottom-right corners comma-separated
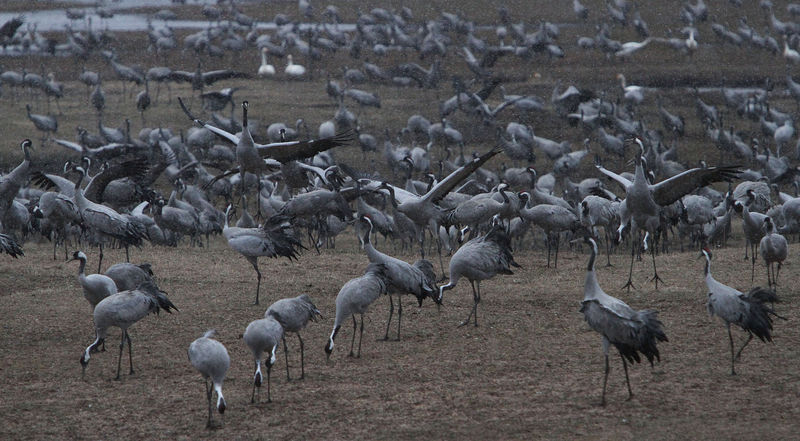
(359, 215, 436, 340)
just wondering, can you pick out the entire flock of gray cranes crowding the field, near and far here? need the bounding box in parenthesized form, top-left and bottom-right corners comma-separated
(0, 0, 800, 432)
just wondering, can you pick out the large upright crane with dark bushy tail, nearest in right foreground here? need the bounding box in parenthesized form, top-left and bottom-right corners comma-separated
(580, 237, 668, 405)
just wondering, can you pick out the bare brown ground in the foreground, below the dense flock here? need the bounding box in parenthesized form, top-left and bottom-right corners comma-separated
(0, 234, 800, 439)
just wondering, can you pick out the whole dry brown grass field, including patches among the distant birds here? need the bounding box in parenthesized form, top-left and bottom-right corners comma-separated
(0, 0, 800, 440)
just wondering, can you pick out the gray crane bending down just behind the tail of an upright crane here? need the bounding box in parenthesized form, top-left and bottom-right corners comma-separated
(437, 217, 519, 326)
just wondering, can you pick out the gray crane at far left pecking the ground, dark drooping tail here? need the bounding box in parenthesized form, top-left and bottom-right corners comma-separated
(81, 283, 178, 380)
